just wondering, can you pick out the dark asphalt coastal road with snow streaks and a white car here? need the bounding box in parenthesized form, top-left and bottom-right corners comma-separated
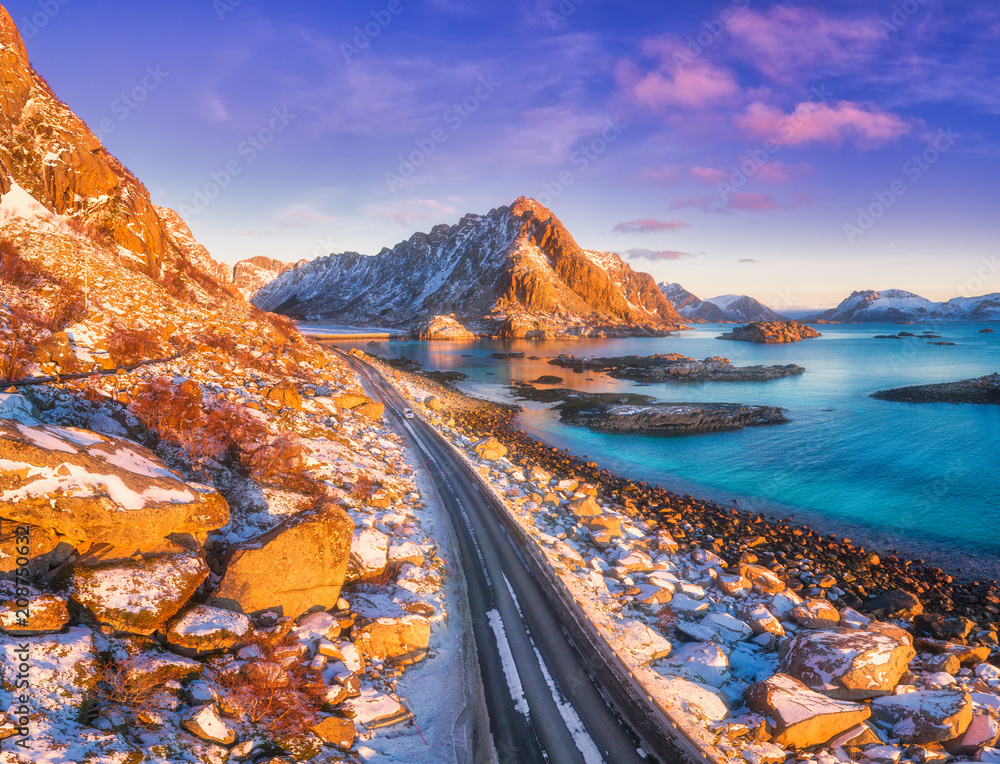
(343, 355, 682, 764)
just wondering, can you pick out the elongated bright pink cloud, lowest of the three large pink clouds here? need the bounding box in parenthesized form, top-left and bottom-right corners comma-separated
(736, 101, 910, 148)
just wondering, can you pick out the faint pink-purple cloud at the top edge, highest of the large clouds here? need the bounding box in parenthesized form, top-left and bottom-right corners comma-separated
(729, 5, 882, 83)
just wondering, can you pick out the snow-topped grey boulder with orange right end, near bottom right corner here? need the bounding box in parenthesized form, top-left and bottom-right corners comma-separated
(871, 690, 972, 745)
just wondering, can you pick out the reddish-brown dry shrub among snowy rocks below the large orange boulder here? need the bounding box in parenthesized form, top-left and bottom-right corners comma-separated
(215, 635, 327, 735)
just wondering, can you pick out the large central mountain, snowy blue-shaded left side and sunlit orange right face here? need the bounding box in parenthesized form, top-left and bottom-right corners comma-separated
(252, 197, 682, 337)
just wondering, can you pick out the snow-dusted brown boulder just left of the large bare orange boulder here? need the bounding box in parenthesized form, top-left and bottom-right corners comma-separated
(71, 554, 209, 635)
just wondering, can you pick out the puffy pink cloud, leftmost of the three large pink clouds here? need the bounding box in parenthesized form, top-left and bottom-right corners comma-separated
(615, 37, 740, 114)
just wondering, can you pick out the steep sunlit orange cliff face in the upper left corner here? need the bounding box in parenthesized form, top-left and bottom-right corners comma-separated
(0, 7, 170, 275)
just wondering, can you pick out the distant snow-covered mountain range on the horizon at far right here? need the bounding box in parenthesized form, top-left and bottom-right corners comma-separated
(815, 289, 1000, 323)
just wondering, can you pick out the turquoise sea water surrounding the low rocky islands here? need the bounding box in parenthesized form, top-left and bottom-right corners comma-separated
(328, 323, 1000, 578)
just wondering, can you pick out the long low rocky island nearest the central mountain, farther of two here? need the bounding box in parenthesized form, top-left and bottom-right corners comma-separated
(549, 353, 805, 382)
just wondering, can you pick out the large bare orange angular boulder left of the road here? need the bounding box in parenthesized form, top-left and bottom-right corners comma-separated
(212, 504, 354, 618)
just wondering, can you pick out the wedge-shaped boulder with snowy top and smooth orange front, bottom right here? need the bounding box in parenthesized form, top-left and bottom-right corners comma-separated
(746, 674, 871, 748)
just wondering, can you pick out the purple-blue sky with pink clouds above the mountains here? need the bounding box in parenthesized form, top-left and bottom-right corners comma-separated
(5, 0, 1000, 310)
